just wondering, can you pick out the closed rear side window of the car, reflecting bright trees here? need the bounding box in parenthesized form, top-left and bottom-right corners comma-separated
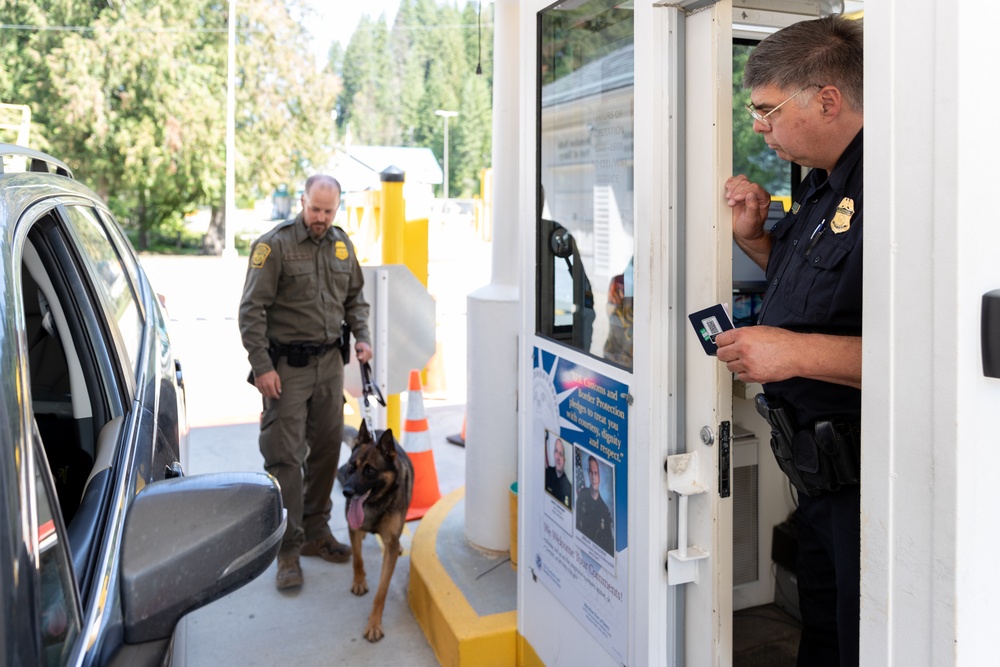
(66, 206, 143, 376)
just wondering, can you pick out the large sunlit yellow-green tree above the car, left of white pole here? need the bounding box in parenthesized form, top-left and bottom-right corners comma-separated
(37, 3, 218, 247)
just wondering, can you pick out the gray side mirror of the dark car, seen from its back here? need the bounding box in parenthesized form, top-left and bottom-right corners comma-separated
(121, 472, 285, 644)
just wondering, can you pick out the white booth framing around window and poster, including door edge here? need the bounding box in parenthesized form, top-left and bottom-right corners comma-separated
(518, 0, 732, 666)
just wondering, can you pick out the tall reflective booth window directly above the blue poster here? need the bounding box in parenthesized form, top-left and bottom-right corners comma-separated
(535, 0, 635, 369)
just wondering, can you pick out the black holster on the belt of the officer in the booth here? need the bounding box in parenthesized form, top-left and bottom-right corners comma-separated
(754, 394, 861, 496)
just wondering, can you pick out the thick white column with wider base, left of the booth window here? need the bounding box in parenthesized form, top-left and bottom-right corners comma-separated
(465, 0, 520, 561)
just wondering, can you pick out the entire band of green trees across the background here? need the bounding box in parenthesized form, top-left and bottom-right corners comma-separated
(0, 0, 493, 249)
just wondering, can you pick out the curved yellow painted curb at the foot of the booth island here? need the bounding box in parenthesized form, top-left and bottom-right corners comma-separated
(407, 487, 518, 667)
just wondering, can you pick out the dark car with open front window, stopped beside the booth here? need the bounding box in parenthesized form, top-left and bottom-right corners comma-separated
(0, 144, 285, 666)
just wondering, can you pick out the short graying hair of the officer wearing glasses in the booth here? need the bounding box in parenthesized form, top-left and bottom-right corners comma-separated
(743, 16, 865, 112)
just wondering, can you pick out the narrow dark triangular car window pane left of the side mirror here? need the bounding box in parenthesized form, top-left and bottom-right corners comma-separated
(35, 438, 80, 665)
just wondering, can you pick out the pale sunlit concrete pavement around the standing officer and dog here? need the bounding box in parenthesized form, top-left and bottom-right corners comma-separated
(141, 245, 489, 667)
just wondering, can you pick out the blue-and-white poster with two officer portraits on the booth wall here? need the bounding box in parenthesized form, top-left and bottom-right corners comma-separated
(525, 347, 628, 664)
